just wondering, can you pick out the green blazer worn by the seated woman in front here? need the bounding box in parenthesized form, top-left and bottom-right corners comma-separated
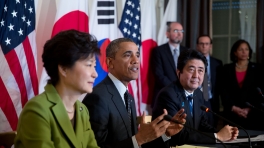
(15, 84, 98, 148)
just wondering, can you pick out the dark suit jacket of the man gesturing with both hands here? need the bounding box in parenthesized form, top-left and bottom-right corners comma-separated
(83, 76, 137, 148)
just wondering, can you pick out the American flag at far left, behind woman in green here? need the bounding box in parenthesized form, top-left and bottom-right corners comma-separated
(0, 0, 38, 132)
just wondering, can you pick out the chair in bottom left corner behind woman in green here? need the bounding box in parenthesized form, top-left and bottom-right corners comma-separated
(0, 131, 17, 148)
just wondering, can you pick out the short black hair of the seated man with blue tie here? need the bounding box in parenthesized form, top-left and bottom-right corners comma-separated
(177, 49, 208, 72)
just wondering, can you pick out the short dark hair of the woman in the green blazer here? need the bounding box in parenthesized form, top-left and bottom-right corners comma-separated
(42, 29, 100, 85)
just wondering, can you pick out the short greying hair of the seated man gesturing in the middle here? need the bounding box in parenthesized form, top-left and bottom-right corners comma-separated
(106, 38, 134, 58)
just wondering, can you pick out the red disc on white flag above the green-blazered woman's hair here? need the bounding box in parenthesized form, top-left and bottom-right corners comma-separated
(52, 10, 89, 37)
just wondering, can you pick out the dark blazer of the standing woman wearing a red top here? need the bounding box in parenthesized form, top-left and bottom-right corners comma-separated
(221, 62, 264, 130)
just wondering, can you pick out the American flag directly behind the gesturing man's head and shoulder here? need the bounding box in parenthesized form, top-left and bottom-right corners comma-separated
(118, 0, 141, 115)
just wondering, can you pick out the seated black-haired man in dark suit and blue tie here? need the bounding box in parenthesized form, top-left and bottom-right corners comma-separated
(152, 49, 238, 145)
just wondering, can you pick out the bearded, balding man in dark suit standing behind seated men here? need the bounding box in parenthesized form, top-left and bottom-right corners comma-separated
(151, 22, 187, 107)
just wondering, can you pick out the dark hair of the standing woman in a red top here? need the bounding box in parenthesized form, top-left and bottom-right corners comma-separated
(230, 39, 253, 63)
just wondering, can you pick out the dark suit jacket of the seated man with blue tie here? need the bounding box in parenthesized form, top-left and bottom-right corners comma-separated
(152, 80, 216, 146)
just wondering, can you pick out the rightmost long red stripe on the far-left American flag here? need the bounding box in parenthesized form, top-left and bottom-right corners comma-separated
(22, 36, 38, 95)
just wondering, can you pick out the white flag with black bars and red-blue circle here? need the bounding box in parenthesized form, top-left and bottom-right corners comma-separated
(89, 0, 122, 85)
